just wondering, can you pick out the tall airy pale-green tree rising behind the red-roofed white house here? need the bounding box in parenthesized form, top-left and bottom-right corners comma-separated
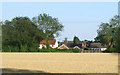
(32, 13, 63, 40)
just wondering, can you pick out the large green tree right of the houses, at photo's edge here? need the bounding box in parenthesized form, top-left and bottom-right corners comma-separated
(95, 15, 120, 50)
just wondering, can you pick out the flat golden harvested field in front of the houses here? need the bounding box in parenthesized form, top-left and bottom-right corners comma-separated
(0, 52, 118, 73)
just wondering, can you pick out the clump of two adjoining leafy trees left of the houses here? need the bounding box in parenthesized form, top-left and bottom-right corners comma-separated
(0, 13, 64, 52)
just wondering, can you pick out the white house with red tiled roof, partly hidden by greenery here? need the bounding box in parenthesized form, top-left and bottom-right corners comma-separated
(39, 40, 58, 49)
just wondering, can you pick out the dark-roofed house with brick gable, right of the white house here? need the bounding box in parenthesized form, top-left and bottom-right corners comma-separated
(58, 42, 82, 49)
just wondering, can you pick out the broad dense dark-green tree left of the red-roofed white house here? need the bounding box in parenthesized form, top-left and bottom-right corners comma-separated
(2, 17, 44, 51)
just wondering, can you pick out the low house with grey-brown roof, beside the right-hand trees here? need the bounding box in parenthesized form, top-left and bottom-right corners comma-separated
(89, 43, 107, 51)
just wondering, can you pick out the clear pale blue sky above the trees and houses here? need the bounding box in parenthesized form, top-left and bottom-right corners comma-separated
(2, 2, 118, 41)
